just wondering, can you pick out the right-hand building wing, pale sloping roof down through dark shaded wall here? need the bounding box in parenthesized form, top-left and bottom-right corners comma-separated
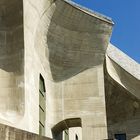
(105, 44, 140, 140)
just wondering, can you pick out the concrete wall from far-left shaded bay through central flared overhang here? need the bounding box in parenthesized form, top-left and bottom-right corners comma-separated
(0, 0, 113, 140)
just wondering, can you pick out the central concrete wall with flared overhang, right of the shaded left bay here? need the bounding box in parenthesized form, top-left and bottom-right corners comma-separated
(24, 0, 112, 140)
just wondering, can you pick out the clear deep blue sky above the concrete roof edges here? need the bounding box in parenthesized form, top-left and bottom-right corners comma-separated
(72, 0, 140, 63)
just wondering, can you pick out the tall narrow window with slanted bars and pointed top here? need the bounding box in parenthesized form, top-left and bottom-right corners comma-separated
(39, 75, 46, 135)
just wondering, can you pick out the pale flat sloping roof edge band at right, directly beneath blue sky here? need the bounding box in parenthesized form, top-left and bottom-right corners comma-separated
(106, 44, 140, 80)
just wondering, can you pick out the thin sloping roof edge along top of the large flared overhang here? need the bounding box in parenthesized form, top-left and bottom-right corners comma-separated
(63, 0, 114, 25)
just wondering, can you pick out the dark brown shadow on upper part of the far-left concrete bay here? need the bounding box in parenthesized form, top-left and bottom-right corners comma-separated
(0, 0, 24, 74)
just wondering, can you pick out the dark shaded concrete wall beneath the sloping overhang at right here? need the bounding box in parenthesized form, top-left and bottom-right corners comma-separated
(104, 61, 140, 140)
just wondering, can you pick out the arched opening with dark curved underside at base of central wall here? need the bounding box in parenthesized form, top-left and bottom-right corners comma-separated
(52, 118, 82, 140)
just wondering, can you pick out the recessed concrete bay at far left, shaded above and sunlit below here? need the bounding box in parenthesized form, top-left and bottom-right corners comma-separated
(0, 0, 25, 118)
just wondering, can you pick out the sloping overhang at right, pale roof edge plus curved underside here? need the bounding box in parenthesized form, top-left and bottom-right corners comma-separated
(105, 44, 140, 99)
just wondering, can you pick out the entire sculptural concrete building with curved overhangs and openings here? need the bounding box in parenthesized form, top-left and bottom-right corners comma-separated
(0, 0, 140, 140)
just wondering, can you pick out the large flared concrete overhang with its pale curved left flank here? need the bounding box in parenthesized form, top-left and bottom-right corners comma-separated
(35, 0, 113, 82)
